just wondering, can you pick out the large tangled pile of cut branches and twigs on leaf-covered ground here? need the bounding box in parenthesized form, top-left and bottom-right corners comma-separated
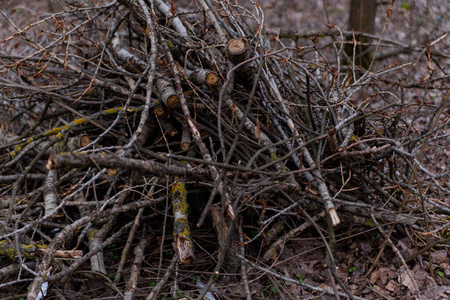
(0, 0, 450, 299)
